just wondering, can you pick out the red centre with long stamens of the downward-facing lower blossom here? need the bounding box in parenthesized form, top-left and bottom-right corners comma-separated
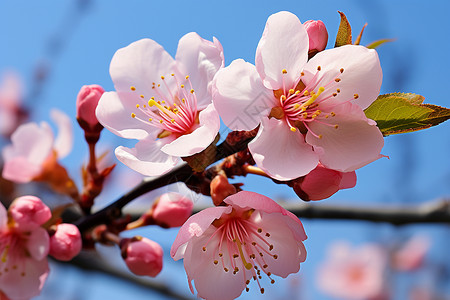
(202, 213, 278, 293)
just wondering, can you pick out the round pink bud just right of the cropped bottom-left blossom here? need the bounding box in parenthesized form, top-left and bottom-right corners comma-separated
(49, 223, 82, 261)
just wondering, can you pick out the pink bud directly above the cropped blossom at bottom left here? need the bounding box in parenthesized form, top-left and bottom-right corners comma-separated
(9, 196, 52, 231)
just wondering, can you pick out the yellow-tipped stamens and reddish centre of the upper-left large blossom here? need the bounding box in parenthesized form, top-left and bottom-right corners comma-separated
(126, 73, 198, 138)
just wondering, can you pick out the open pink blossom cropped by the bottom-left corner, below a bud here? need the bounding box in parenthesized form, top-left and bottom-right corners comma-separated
(0, 196, 50, 300)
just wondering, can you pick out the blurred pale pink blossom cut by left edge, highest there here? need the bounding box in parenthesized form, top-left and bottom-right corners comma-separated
(0, 72, 23, 136)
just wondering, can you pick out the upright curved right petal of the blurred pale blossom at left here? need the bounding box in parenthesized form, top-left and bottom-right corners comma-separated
(50, 109, 73, 158)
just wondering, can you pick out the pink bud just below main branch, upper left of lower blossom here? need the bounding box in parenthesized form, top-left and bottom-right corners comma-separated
(152, 192, 194, 227)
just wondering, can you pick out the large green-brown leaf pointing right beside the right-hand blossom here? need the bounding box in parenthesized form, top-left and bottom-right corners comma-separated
(364, 93, 450, 136)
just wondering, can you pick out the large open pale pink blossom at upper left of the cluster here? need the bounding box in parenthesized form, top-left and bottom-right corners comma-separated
(96, 32, 224, 176)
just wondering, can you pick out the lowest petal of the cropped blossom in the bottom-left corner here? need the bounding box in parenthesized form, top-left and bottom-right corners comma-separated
(0, 258, 49, 300)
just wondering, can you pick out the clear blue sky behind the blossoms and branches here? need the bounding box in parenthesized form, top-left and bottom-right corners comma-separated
(0, 0, 450, 299)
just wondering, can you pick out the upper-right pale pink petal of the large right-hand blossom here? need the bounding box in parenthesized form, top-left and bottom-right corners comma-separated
(304, 45, 383, 109)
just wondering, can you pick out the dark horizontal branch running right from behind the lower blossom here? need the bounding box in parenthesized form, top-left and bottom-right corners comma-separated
(191, 199, 450, 225)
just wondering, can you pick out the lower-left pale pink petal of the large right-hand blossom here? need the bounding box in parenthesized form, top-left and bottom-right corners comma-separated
(248, 118, 319, 180)
